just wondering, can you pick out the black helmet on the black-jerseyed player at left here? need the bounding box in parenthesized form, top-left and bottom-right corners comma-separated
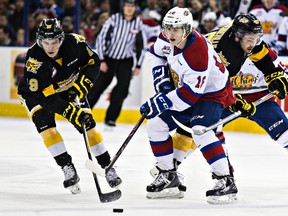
(36, 18, 65, 47)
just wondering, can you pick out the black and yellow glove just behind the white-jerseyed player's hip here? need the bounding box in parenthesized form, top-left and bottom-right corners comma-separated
(229, 94, 256, 117)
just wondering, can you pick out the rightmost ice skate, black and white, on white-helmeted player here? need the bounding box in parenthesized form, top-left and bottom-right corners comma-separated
(206, 173, 238, 204)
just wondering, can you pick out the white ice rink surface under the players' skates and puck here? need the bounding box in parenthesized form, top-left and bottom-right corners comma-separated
(0, 117, 288, 216)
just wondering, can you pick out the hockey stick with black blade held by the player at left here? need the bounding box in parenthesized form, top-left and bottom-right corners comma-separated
(76, 97, 122, 203)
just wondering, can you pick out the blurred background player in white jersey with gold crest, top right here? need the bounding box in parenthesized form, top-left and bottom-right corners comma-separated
(249, 0, 288, 52)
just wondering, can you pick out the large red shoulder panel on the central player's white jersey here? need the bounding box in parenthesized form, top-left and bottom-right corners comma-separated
(183, 31, 208, 71)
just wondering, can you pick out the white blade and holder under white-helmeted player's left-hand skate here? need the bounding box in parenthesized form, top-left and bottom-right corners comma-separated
(146, 187, 184, 199)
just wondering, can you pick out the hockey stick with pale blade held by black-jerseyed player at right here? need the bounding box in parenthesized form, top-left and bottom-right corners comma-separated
(172, 93, 274, 135)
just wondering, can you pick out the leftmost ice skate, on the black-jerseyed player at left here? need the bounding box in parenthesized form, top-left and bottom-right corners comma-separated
(62, 164, 81, 194)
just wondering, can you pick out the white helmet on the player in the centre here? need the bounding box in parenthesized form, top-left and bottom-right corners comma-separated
(162, 7, 193, 34)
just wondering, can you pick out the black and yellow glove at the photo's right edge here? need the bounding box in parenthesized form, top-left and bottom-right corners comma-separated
(265, 67, 288, 99)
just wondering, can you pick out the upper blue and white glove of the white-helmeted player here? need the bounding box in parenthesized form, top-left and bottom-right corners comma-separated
(152, 65, 174, 94)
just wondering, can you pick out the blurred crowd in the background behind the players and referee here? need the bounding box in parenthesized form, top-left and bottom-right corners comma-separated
(0, 0, 288, 54)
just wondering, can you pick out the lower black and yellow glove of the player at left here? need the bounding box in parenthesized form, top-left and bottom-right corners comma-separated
(62, 102, 96, 133)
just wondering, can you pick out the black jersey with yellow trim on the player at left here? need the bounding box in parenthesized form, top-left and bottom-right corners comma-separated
(18, 34, 100, 113)
